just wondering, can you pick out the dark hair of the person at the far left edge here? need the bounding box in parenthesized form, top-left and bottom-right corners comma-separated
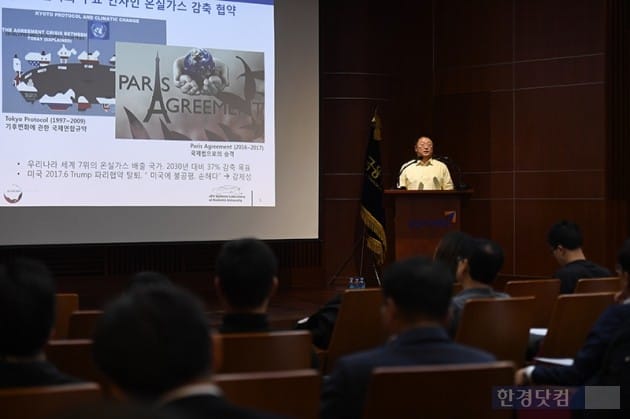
(0, 259, 55, 357)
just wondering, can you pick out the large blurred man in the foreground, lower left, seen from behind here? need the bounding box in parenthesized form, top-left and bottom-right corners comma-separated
(93, 286, 278, 419)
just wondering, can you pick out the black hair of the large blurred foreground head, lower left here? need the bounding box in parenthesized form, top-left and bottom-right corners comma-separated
(93, 286, 211, 400)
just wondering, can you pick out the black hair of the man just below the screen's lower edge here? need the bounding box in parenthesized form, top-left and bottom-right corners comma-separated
(215, 238, 278, 309)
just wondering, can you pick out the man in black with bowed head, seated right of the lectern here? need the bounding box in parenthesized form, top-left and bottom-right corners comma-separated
(547, 221, 612, 294)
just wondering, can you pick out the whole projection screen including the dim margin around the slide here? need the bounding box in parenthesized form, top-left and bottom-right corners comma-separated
(0, 0, 321, 246)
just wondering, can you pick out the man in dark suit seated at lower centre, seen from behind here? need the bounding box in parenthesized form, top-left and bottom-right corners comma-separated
(321, 258, 495, 419)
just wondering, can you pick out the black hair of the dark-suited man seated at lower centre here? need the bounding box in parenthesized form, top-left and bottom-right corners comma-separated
(383, 257, 455, 320)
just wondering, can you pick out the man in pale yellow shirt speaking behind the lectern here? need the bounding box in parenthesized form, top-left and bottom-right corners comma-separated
(398, 137, 453, 190)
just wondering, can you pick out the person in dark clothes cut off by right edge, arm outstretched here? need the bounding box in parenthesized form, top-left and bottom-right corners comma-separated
(515, 241, 630, 386)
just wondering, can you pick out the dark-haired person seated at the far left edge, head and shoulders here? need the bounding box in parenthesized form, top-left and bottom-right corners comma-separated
(0, 259, 79, 388)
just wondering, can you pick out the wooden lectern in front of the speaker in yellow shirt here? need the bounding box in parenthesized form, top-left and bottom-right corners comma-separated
(385, 189, 472, 260)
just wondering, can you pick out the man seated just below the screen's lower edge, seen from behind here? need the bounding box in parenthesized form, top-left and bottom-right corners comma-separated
(214, 238, 278, 333)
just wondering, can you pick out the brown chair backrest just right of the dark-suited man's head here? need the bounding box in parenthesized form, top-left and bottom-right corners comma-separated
(455, 297, 535, 366)
